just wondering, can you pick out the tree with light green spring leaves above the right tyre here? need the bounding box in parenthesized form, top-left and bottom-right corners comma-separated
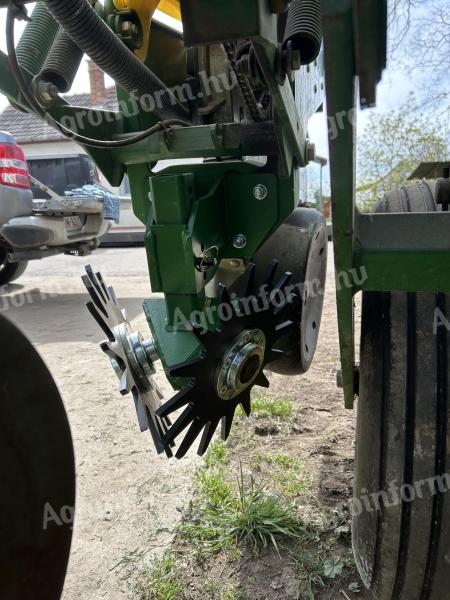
(357, 102, 449, 208)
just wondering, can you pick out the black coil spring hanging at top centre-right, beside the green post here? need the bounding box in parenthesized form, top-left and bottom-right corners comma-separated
(284, 0, 322, 65)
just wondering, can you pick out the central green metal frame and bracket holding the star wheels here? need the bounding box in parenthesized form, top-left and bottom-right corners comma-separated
(0, 0, 323, 376)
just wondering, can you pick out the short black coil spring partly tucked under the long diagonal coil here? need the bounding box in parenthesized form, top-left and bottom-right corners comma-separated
(35, 28, 83, 94)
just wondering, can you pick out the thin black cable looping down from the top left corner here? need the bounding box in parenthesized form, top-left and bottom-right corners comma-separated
(6, 4, 190, 149)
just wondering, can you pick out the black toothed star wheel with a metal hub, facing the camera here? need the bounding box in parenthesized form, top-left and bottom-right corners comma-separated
(157, 261, 300, 458)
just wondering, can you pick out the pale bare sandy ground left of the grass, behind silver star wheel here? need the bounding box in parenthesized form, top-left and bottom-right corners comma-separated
(0, 248, 199, 600)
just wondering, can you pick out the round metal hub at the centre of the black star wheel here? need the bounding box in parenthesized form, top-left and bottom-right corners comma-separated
(217, 329, 266, 400)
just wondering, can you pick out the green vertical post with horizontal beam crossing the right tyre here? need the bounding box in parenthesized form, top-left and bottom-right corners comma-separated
(322, 0, 450, 408)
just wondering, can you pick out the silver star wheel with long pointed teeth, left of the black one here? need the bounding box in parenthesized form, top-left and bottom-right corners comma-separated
(82, 265, 172, 457)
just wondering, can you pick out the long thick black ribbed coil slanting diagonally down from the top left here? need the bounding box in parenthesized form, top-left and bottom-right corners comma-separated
(45, 0, 189, 119)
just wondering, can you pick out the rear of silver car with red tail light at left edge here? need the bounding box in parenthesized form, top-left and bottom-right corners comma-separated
(0, 132, 113, 285)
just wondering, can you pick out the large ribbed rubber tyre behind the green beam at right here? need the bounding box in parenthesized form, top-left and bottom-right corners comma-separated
(353, 181, 450, 600)
